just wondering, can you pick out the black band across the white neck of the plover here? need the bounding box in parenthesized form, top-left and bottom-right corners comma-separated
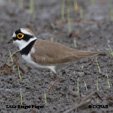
(20, 40, 36, 55)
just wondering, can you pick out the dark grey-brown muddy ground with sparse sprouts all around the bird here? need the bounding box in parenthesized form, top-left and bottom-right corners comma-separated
(0, 0, 113, 113)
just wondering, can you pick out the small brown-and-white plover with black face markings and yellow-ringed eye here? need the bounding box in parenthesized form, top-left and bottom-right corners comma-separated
(9, 28, 101, 74)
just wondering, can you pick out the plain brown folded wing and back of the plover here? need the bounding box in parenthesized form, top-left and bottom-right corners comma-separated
(32, 40, 97, 65)
